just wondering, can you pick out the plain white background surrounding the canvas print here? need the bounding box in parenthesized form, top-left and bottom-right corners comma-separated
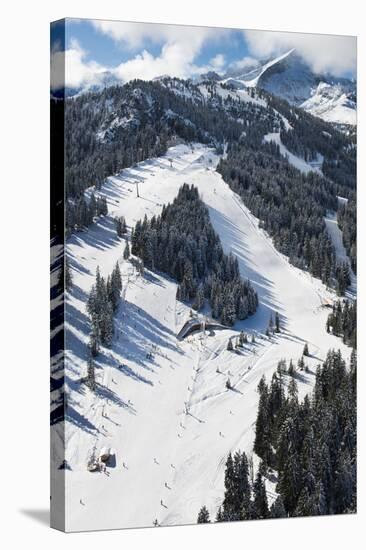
(0, 0, 366, 550)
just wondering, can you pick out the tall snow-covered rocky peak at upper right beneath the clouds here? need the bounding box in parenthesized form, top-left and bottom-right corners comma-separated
(222, 50, 356, 125)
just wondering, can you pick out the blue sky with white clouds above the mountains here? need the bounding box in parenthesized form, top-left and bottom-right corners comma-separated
(53, 19, 356, 86)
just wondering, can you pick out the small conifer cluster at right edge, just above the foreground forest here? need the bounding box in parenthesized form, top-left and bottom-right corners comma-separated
(327, 300, 357, 348)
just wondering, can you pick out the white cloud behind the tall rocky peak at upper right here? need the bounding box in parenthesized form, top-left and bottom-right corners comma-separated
(243, 31, 357, 76)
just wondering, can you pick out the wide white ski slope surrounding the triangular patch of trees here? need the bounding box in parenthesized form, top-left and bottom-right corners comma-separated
(60, 144, 349, 531)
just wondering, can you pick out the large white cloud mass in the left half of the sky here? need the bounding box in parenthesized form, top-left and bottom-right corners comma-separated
(53, 21, 230, 87)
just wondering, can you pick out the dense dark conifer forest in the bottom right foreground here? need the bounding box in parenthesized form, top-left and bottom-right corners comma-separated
(198, 351, 357, 523)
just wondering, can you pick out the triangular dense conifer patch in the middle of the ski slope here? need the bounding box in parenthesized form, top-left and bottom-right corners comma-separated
(131, 184, 258, 326)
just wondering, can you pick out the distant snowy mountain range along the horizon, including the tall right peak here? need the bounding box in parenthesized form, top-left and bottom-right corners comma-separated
(58, 49, 357, 125)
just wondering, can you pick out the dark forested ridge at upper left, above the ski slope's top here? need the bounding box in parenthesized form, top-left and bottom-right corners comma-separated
(65, 79, 279, 203)
